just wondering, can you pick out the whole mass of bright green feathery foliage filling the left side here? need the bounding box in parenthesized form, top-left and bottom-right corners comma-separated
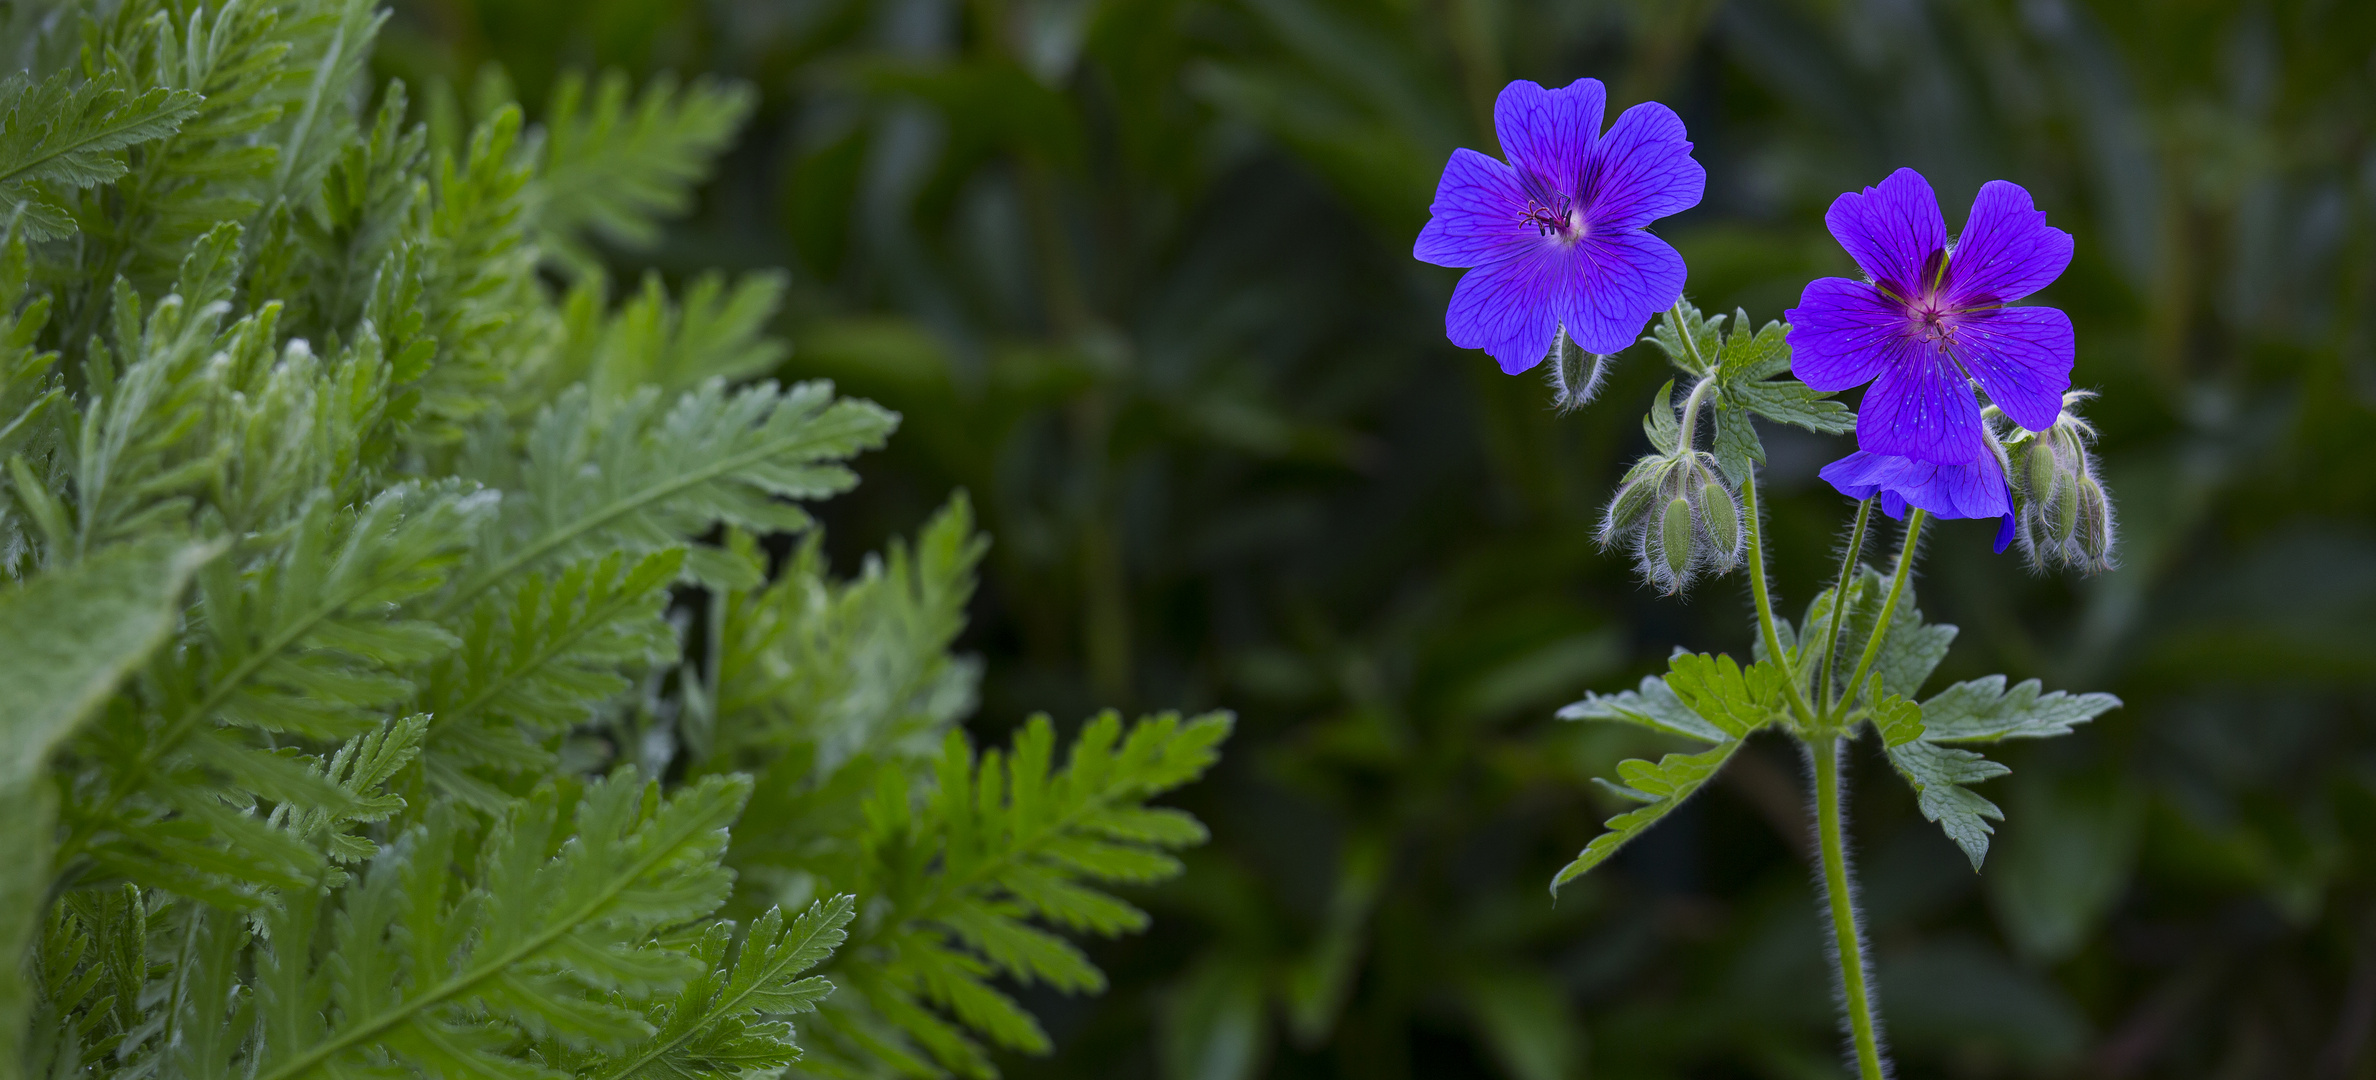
(0, 0, 1224, 1080)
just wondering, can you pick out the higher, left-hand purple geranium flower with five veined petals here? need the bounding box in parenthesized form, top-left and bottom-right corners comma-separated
(1411, 78, 1708, 375)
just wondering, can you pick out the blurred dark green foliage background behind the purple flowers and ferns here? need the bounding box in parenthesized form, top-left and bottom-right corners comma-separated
(378, 0, 2376, 1080)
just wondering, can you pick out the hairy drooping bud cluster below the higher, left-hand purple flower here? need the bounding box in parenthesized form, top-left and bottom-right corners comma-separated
(1597, 451, 1744, 596)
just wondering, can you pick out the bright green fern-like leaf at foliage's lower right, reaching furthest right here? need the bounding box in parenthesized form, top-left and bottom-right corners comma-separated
(808, 712, 1228, 1078)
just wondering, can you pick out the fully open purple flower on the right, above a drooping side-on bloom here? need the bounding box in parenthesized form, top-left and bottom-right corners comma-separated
(1782, 169, 2074, 465)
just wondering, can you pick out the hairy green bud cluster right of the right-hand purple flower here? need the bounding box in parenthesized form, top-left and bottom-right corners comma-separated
(2005, 389, 2112, 574)
